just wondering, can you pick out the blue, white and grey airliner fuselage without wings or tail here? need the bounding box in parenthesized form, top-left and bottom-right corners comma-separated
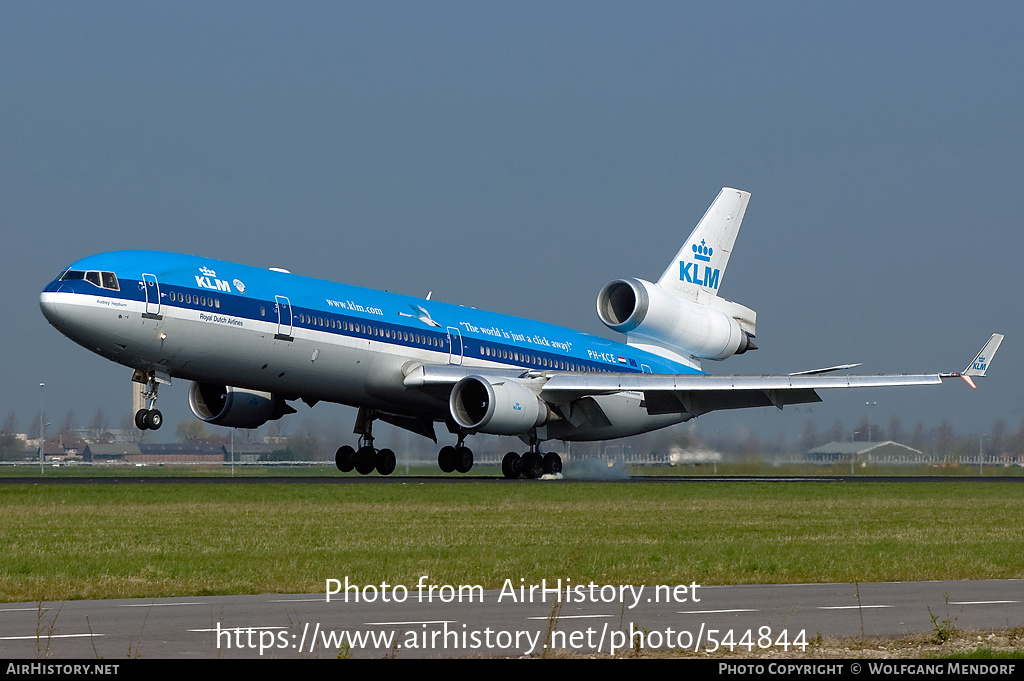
(40, 251, 696, 439)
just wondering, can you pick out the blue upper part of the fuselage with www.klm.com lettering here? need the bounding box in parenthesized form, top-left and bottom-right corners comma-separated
(45, 252, 697, 374)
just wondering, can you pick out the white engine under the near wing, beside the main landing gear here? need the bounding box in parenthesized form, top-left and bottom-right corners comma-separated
(449, 376, 550, 435)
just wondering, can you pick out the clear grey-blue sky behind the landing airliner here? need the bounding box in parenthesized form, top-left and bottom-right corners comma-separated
(0, 2, 1024, 448)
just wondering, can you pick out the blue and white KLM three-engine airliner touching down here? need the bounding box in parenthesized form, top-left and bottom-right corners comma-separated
(40, 188, 1002, 478)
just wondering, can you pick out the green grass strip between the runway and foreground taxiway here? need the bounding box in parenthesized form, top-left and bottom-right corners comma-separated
(0, 481, 1024, 602)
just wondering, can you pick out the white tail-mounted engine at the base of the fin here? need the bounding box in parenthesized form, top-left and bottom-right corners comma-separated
(597, 279, 757, 359)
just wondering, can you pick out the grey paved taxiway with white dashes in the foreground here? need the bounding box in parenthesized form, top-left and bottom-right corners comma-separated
(0, 576, 1024, 659)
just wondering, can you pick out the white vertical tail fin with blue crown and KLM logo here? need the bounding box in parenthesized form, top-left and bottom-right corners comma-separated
(657, 187, 751, 301)
